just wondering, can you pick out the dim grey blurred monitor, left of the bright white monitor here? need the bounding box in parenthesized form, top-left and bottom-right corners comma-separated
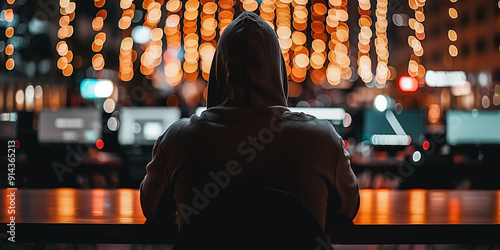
(38, 108, 101, 144)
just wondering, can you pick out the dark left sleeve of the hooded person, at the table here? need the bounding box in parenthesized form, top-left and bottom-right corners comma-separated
(140, 136, 170, 220)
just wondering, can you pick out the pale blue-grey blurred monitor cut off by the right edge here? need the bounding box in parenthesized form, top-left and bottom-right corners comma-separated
(446, 110, 500, 145)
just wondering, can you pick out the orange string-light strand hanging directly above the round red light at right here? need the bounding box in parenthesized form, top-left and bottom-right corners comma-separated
(408, 0, 425, 84)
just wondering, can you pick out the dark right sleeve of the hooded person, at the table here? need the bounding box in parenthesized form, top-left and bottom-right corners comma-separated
(327, 135, 360, 224)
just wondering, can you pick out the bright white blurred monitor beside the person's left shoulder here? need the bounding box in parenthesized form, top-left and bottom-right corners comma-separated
(118, 107, 181, 146)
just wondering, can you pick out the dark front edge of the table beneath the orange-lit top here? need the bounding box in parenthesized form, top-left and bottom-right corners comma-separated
(2, 223, 500, 244)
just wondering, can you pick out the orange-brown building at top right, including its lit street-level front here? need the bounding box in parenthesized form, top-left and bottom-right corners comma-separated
(422, 0, 500, 110)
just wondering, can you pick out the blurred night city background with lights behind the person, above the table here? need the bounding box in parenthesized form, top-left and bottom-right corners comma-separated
(0, 0, 500, 189)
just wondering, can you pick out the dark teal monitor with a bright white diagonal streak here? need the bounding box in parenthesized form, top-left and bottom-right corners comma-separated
(362, 109, 425, 147)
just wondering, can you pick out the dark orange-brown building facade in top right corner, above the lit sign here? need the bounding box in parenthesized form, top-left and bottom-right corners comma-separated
(423, 0, 500, 74)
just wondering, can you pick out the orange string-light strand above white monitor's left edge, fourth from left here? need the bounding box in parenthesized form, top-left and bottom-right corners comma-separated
(118, 0, 137, 82)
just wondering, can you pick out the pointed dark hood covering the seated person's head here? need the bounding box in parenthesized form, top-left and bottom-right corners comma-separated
(207, 11, 288, 108)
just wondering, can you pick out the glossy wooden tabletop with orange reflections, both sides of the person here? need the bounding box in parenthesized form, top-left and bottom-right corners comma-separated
(0, 188, 500, 225)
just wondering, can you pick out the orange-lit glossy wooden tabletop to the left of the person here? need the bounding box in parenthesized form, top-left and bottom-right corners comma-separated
(0, 188, 146, 224)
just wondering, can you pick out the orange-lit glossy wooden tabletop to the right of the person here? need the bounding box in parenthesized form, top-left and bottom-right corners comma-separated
(354, 189, 500, 225)
